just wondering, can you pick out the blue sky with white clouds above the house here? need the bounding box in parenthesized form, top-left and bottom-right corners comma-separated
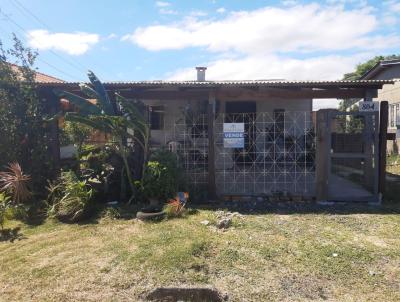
(0, 0, 400, 98)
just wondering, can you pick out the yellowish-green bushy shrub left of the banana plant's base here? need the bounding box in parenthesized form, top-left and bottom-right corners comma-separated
(48, 171, 93, 222)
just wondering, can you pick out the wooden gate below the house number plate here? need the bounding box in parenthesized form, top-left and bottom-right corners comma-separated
(317, 110, 379, 202)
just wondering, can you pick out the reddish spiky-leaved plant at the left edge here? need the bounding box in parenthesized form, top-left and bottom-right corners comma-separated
(0, 163, 31, 204)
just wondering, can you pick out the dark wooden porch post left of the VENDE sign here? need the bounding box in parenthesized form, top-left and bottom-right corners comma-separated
(207, 90, 217, 200)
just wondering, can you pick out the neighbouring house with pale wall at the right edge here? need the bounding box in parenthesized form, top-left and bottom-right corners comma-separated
(361, 60, 400, 153)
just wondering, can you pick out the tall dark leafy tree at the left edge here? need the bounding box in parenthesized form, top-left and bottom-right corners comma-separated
(0, 35, 52, 190)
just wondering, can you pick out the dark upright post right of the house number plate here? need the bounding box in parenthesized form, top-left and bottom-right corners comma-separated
(378, 101, 389, 195)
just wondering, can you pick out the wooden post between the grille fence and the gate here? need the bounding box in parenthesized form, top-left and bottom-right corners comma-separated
(315, 109, 331, 200)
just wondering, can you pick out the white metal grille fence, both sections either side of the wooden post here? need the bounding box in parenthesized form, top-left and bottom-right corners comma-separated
(152, 111, 315, 196)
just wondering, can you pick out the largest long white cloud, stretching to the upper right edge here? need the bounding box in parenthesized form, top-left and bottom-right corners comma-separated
(124, 3, 400, 54)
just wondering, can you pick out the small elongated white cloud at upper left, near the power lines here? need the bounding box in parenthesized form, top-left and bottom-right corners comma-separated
(28, 29, 100, 55)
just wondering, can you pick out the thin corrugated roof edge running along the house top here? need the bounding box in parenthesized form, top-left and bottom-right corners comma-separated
(36, 80, 394, 87)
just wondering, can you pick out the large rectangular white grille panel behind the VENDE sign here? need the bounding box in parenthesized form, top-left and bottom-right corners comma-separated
(214, 111, 315, 196)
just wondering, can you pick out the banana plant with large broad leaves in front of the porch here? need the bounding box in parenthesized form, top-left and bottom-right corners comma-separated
(54, 71, 149, 202)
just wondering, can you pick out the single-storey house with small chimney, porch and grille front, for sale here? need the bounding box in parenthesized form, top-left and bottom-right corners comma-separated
(40, 67, 393, 201)
